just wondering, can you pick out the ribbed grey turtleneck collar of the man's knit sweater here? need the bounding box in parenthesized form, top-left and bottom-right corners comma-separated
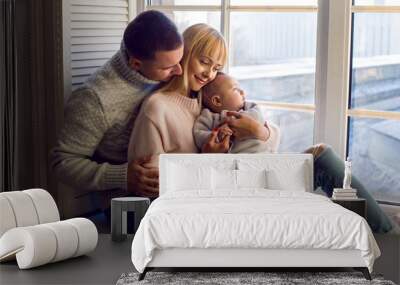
(111, 42, 160, 86)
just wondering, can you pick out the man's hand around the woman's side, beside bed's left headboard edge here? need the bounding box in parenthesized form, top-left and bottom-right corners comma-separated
(128, 156, 159, 198)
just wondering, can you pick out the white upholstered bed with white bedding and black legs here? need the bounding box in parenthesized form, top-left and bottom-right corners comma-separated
(132, 154, 380, 280)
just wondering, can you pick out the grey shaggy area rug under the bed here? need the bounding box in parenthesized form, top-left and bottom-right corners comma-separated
(117, 272, 395, 285)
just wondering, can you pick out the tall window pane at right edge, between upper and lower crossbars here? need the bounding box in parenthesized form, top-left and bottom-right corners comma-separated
(350, 13, 400, 111)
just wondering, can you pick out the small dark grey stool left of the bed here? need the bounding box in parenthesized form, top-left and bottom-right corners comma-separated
(111, 197, 150, 241)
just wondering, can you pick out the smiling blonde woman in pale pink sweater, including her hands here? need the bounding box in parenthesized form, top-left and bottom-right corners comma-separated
(128, 24, 274, 167)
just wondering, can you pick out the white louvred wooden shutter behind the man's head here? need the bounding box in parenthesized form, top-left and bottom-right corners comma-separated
(63, 0, 135, 98)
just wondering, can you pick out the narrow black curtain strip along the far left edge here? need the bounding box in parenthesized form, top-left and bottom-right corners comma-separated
(0, 0, 16, 191)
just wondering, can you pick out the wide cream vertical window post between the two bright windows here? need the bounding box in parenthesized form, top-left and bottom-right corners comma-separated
(314, 0, 352, 159)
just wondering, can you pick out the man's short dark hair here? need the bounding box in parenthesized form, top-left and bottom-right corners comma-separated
(124, 10, 183, 60)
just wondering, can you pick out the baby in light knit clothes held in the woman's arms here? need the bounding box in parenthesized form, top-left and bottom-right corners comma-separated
(193, 73, 279, 153)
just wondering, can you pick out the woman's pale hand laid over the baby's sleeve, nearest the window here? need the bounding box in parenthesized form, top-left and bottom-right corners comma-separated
(225, 111, 270, 141)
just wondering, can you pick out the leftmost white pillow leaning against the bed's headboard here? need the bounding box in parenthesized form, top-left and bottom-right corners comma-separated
(167, 163, 212, 191)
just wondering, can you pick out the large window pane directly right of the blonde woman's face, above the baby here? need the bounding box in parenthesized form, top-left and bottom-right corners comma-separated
(229, 12, 317, 104)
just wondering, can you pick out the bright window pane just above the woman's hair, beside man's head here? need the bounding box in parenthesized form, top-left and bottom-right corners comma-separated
(162, 11, 221, 33)
